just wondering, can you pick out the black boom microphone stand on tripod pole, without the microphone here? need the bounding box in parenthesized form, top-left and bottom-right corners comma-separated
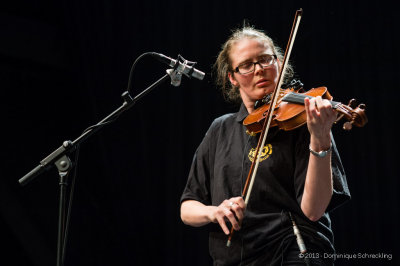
(18, 67, 182, 266)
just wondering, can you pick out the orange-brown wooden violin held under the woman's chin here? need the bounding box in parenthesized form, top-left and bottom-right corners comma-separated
(243, 87, 368, 135)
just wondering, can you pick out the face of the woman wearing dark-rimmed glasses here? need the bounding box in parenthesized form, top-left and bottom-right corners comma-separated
(228, 39, 279, 108)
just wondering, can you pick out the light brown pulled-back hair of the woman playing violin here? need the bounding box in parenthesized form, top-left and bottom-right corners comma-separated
(214, 26, 293, 103)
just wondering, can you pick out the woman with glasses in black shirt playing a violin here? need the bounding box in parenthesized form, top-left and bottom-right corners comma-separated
(181, 27, 350, 265)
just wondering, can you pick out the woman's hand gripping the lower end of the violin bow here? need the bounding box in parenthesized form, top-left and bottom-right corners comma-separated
(210, 197, 246, 235)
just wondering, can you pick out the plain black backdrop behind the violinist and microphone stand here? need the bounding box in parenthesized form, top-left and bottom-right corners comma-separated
(0, 0, 400, 266)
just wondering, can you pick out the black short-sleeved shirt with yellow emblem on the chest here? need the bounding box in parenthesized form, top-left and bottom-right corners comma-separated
(181, 104, 350, 265)
